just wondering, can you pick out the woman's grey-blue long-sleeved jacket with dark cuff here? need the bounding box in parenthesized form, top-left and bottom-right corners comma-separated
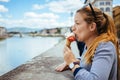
(75, 41, 117, 80)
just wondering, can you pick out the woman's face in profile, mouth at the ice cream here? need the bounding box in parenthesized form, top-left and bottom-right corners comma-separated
(72, 13, 92, 42)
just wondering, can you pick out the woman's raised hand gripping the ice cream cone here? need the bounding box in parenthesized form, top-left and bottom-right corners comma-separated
(64, 46, 78, 65)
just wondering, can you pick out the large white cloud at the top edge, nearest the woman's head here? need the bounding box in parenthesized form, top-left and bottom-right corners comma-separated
(46, 0, 82, 13)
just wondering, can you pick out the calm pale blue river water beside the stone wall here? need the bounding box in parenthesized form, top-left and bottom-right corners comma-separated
(0, 37, 61, 75)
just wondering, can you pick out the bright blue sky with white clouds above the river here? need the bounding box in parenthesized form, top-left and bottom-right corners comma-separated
(0, 0, 120, 28)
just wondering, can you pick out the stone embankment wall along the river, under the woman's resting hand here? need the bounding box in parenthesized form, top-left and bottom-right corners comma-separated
(0, 40, 78, 80)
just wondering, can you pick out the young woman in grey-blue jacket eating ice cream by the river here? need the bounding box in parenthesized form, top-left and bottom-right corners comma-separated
(56, 4, 119, 80)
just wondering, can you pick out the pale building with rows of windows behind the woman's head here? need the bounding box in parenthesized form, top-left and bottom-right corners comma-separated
(92, 0, 113, 16)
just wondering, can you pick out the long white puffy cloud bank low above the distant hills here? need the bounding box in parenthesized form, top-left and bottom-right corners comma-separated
(0, 12, 65, 28)
